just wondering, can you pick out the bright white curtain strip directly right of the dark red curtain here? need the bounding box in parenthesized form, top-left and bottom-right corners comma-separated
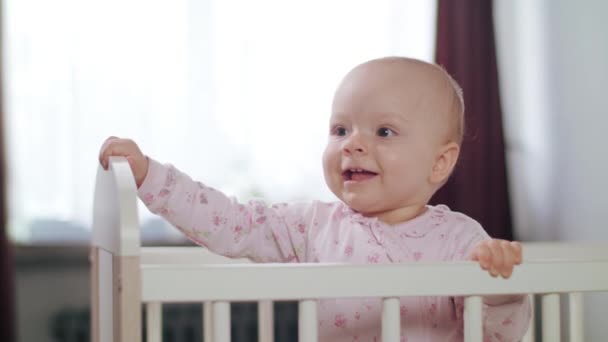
(494, 0, 558, 240)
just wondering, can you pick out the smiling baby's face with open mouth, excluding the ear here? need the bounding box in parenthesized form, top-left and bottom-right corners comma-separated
(323, 58, 454, 223)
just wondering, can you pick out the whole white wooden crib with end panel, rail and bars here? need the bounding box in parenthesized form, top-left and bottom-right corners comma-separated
(91, 157, 608, 342)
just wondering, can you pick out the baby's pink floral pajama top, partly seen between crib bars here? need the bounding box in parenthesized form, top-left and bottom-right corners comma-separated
(139, 159, 530, 342)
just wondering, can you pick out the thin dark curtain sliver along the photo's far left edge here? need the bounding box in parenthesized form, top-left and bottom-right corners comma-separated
(0, 3, 15, 342)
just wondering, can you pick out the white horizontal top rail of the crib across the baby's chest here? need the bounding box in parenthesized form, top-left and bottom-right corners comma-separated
(142, 260, 608, 302)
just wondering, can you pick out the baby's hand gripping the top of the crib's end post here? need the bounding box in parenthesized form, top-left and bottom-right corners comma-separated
(99, 137, 148, 188)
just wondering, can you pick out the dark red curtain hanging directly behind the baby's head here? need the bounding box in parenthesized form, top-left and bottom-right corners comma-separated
(431, 0, 513, 240)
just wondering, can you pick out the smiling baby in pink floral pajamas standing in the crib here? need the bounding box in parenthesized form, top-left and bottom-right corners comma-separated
(99, 57, 530, 342)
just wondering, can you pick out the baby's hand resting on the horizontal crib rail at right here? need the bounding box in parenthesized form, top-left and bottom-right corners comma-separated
(468, 239, 522, 278)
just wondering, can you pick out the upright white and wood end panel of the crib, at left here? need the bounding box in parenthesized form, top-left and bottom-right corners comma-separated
(90, 157, 141, 342)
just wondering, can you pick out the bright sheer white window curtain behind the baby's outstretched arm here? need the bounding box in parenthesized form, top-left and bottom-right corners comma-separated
(4, 0, 436, 242)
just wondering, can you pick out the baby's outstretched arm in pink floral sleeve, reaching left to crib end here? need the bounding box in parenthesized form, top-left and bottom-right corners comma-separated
(100, 138, 307, 262)
